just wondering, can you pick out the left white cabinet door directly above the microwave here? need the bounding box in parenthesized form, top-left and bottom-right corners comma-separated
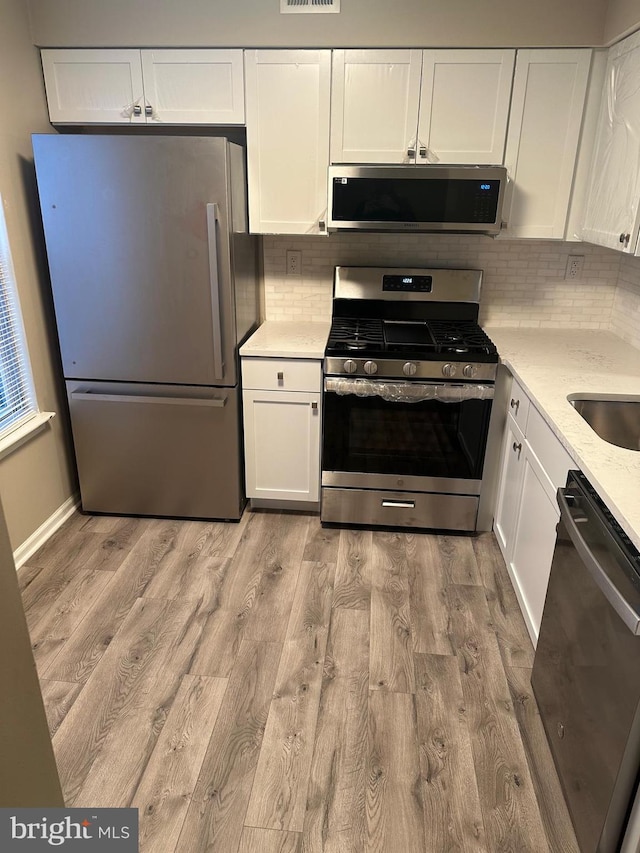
(331, 50, 422, 163)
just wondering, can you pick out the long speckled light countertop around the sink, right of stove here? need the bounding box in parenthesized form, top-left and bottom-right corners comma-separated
(485, 325, 640, 548)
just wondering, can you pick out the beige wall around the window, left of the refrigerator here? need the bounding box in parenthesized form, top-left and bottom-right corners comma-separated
(0, 0, 76, 550)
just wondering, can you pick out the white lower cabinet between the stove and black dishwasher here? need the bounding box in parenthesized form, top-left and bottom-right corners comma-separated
(494, 370, 575, 645)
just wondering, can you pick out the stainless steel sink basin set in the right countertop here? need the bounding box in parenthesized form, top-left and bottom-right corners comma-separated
(567, 394, 640, 450)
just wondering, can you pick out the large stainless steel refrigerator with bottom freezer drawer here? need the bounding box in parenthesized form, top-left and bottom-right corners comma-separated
(33, 134, 258, 519)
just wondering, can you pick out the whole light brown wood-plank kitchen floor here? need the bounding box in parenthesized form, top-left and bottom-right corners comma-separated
(19, 511, 578, 853)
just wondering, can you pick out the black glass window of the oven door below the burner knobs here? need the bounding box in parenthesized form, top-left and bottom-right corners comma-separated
(322, 392, 491, 479)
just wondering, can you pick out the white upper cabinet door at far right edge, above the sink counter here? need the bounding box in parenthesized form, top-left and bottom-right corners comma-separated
(581, 33, 640, 253)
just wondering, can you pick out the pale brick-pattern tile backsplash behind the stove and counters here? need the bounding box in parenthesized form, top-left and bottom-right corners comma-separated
(263, 233, 640, 346)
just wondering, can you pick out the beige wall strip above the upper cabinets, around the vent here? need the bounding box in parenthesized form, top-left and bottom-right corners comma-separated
(28, 0, 608, 47)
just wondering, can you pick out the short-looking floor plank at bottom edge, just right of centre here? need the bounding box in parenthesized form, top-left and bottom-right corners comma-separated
(366, 690, 426, 853)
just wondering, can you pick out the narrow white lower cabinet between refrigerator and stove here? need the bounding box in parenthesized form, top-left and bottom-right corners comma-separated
(242, 358, 322, 503)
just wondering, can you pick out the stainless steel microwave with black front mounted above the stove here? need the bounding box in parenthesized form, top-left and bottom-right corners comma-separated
(327, 165, 507, 235)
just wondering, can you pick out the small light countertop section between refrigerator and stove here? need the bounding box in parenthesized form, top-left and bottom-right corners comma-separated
(240, 320, 331, 358)
